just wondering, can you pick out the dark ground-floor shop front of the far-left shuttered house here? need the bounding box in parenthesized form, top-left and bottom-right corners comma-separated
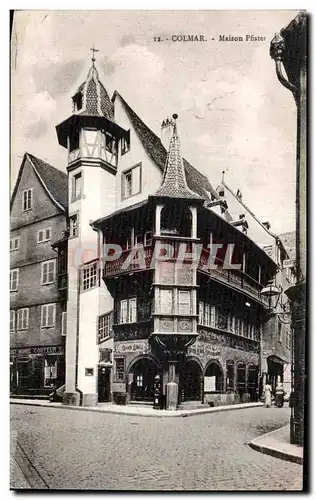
(10, 346, 65, 396)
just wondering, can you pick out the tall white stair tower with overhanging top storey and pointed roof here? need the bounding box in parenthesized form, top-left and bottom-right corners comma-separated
(56, 53, 126, 405)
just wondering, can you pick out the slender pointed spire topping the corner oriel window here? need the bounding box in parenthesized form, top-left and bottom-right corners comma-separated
(156, 114, 201, 199)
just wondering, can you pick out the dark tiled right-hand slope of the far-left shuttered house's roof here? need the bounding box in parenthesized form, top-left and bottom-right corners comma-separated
(26, 153, 68, 210)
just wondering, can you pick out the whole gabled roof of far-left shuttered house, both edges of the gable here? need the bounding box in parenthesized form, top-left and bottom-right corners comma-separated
(10, 153, 68, 212)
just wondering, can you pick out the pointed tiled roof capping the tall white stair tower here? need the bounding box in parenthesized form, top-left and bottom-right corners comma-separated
(75, 64, 114, 121)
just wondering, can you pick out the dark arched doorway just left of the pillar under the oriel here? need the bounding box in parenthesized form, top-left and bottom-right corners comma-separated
(131, 358, 158, 401)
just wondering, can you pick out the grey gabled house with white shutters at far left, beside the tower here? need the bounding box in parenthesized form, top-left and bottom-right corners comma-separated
(10, 153, 68, 396)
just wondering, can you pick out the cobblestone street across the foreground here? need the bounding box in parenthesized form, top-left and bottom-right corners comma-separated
(11, 405, 303, 491)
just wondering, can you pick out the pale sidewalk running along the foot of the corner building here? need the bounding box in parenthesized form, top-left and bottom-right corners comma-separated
(10, 398, 263, 418)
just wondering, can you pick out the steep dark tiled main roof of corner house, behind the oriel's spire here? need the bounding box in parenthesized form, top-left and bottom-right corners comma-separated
(112, 91, 219, 199)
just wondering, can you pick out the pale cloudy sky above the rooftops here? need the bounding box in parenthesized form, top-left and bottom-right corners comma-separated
(11, 10, 298, 234)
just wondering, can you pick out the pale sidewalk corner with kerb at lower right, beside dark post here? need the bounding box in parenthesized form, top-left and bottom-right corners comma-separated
(249, 425, 303, 464)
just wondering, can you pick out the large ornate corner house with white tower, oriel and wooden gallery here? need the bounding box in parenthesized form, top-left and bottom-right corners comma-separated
(56, 60, 290, 405)
